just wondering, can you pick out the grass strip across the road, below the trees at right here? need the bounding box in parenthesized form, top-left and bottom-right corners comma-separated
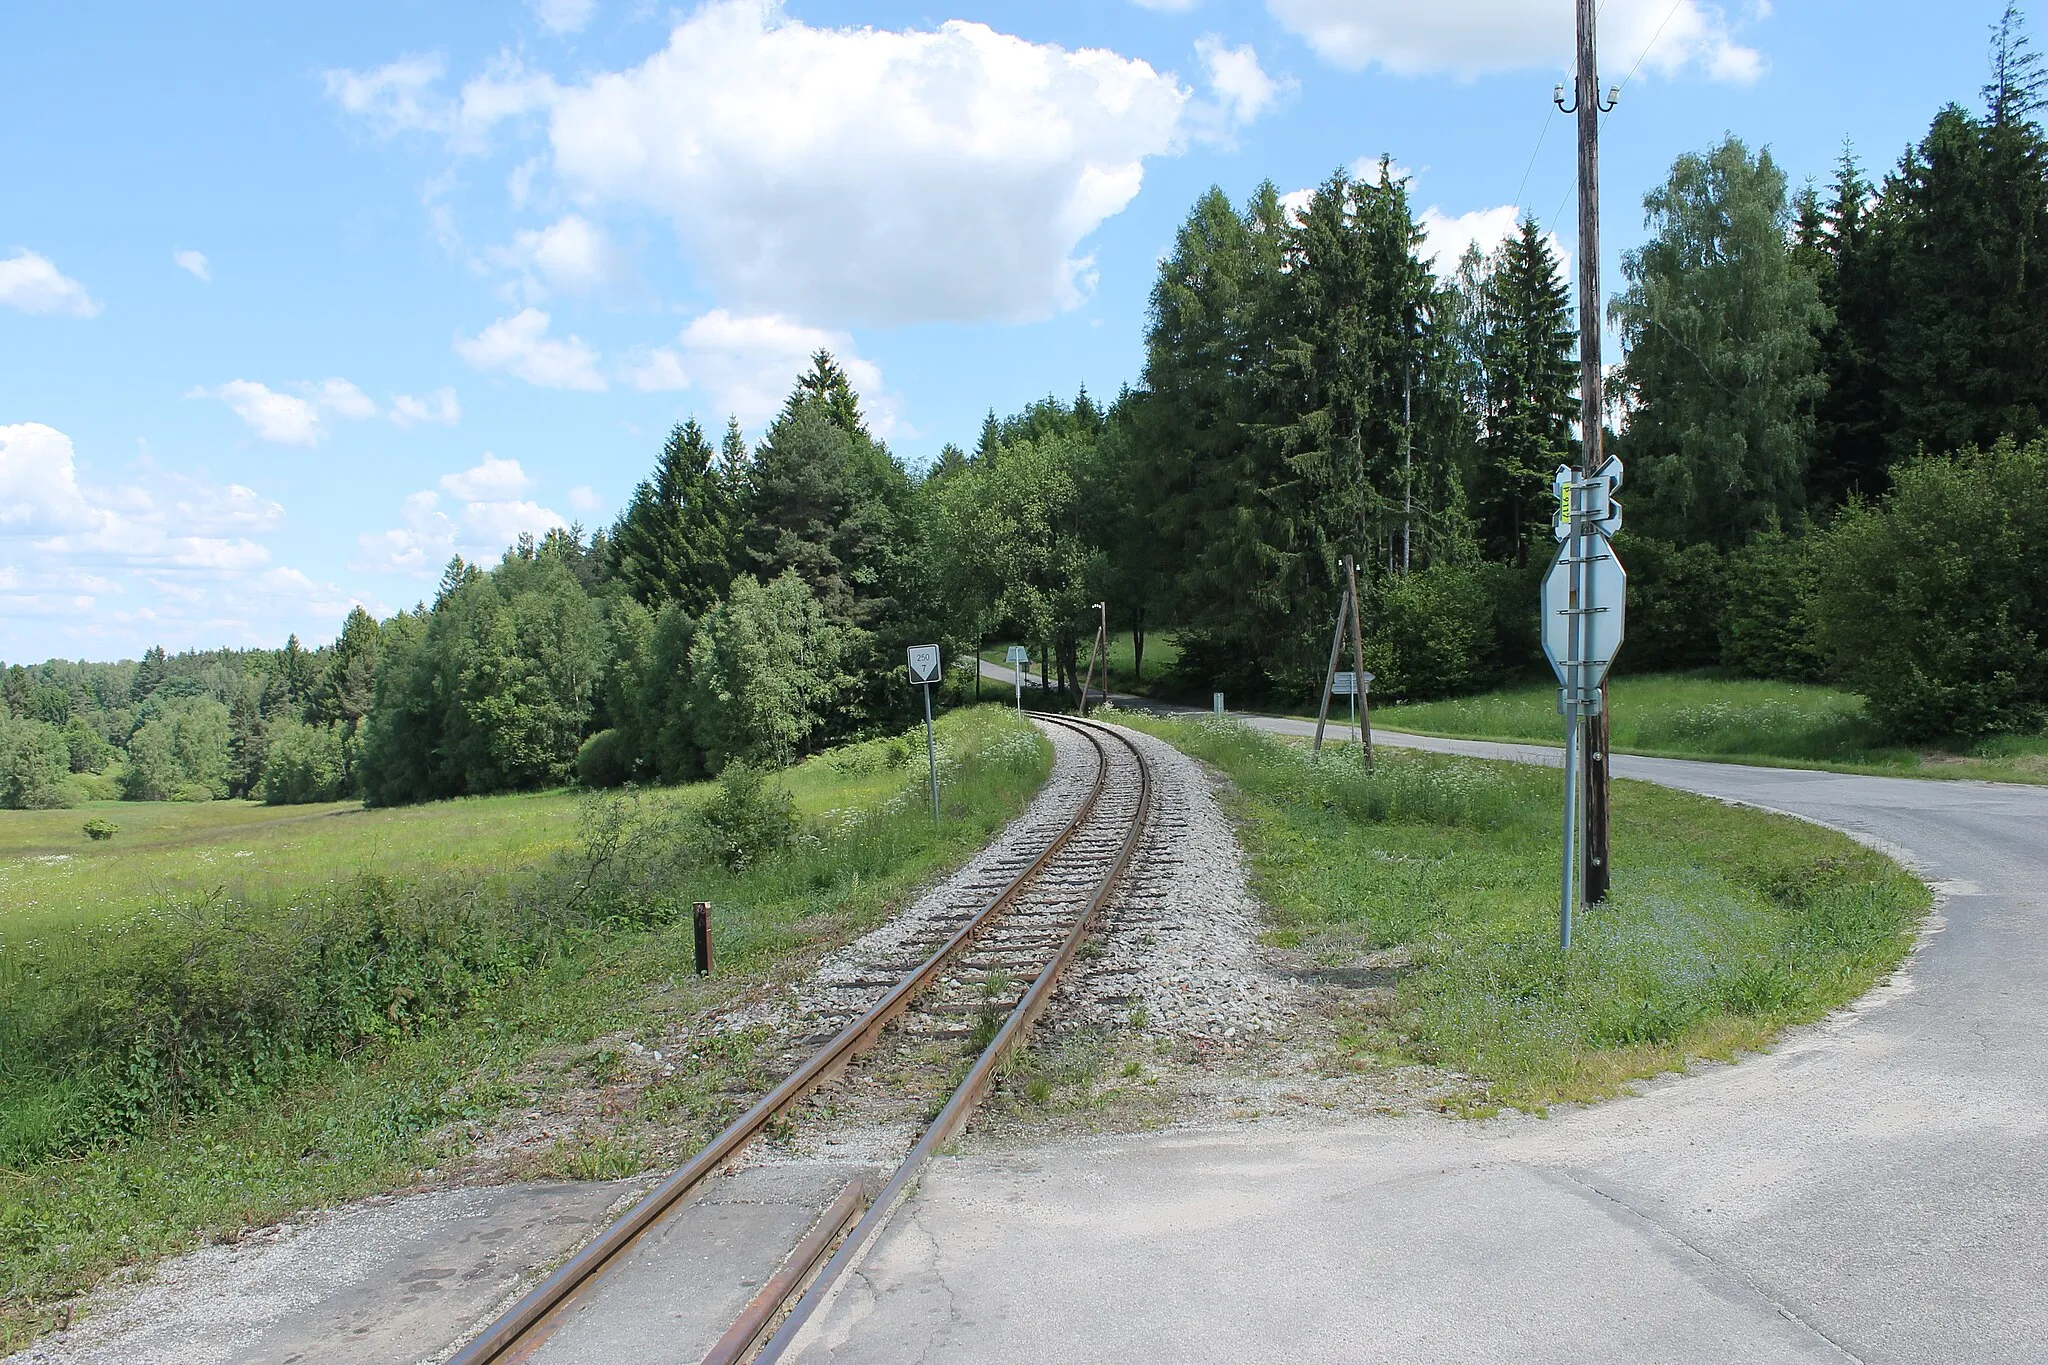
(1372, 673, 2048, 782)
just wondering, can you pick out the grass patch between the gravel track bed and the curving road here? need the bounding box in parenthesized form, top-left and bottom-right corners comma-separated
(1120, 714, 1929, 1113)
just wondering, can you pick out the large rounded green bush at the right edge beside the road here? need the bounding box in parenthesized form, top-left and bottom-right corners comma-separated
(1812, 440, 2048, 741)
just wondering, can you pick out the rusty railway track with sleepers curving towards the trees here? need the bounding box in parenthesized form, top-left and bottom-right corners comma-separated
(451, 716, 1153, 1365)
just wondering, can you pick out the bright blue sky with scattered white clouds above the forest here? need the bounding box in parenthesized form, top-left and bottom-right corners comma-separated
(0, 0, 2001, 661)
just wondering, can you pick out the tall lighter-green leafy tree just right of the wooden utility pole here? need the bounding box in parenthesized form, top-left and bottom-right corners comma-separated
(1614, 137, 1827, 548)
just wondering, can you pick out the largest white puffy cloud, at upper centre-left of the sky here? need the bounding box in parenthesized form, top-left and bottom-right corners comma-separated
(549, 0, 1192, 323)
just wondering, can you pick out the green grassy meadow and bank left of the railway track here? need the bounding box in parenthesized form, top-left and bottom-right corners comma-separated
(0, 706, 1051, 1351)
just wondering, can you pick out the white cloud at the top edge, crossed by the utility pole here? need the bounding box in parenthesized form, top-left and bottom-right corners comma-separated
(1266, 0, 1763, 84)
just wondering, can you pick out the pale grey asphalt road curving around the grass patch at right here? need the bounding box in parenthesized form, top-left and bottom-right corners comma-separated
(797, 677, 2048, 1365)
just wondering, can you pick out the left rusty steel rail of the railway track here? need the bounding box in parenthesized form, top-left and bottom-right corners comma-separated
(449, 716, 1149, 1365)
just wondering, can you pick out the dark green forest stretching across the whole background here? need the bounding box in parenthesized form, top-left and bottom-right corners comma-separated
(0, 10, 2048, 806)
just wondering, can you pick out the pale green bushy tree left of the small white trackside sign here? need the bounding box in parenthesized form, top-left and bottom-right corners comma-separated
(688, 569, 846, 769)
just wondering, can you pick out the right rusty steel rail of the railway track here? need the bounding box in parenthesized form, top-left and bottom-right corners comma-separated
(754, 716, 1151, 1365)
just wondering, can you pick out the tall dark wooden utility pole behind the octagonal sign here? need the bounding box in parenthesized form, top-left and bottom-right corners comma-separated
(1575, 0, 1614, 905)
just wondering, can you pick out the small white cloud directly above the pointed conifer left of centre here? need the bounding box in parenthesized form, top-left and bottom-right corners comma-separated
(631, 309, 895, 436)
